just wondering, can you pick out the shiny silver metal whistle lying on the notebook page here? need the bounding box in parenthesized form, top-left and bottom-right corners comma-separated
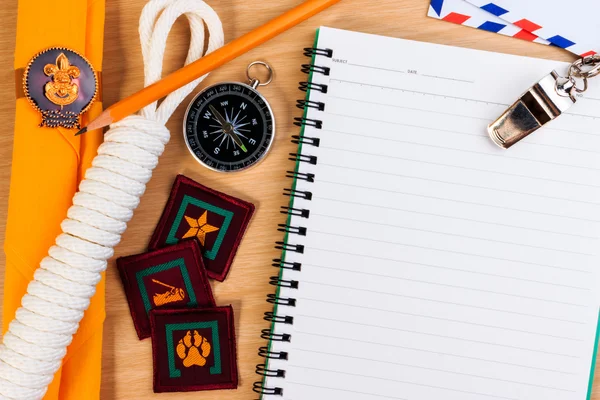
(488, 71, 576, 149)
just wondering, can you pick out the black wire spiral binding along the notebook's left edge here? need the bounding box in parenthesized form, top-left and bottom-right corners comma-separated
(252, 47, 333, 396)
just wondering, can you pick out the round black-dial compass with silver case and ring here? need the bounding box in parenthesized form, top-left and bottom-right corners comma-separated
(183, 61, 275, 172)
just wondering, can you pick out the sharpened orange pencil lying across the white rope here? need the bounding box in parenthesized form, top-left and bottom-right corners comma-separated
(77, 0, 340, 135)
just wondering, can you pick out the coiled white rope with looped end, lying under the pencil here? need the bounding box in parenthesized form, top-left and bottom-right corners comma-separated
(0, 0, 224, 400)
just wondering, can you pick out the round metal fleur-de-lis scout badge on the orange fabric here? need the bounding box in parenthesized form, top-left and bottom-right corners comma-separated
(23, 47, 98, 129)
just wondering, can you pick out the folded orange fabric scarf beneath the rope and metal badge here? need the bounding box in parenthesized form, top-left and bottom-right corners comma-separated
(3, 0, 105, 400)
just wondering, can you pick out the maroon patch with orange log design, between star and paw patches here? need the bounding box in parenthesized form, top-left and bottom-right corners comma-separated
(117, 240, 215, 339)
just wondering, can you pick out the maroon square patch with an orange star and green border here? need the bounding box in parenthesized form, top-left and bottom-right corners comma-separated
(149, 175, 254, 282)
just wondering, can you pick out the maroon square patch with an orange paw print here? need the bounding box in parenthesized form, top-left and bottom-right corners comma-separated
(150, 306, 238, 393)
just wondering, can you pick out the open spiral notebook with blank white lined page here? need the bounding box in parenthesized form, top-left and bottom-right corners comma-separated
(254, 28, 600, 400)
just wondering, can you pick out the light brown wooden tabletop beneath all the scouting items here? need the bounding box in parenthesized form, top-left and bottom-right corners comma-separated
(0, 0, 600, 400)
